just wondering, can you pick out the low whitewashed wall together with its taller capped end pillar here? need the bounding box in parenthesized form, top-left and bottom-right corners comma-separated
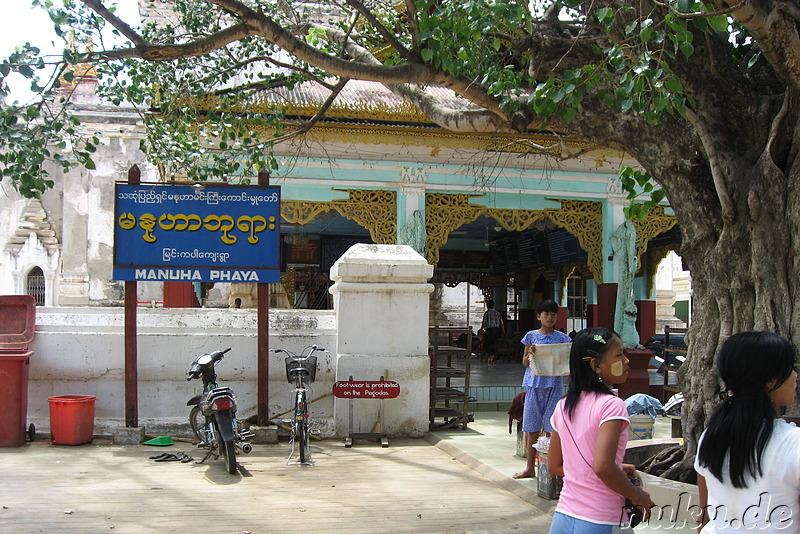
(27, 245, 433, 437)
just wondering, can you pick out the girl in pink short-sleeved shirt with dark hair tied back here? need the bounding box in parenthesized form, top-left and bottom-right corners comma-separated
(547, 328, 653, 534)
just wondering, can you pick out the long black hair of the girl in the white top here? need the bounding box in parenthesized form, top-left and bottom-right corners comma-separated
(697, 332, 797, 488)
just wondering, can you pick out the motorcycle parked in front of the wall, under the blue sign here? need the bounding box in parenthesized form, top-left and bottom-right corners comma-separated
(186, 348, 253, 475)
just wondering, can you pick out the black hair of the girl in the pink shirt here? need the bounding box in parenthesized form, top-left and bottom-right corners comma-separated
(564, 327, 619, 417)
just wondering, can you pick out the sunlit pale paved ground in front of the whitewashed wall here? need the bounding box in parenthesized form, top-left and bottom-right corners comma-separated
(0, 440, 550, 533)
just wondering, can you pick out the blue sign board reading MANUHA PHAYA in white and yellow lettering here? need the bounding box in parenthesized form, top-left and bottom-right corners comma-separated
(114, 183, 280, 283)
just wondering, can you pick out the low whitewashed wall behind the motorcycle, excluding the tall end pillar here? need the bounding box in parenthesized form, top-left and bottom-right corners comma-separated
(28, 308, 336, 435)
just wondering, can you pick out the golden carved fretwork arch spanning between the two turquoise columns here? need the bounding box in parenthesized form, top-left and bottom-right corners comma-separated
(425, 193, 603, 284)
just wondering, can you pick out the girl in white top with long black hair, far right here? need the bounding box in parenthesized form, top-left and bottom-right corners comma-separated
(695, 332, 800, 534)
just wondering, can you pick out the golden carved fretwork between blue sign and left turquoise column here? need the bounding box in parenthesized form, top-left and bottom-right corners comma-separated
(281, 189, 397, 245)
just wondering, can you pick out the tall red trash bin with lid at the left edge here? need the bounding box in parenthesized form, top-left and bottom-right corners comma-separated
(0, 295, 36, 447)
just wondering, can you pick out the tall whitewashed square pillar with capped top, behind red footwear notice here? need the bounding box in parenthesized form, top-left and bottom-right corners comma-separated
(330, 244, 433, 437)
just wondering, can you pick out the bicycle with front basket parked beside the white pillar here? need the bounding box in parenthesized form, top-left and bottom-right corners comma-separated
(272, 345, 325, 465)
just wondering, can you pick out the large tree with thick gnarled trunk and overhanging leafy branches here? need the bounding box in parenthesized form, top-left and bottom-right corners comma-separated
(0, 0, 800, 478)
